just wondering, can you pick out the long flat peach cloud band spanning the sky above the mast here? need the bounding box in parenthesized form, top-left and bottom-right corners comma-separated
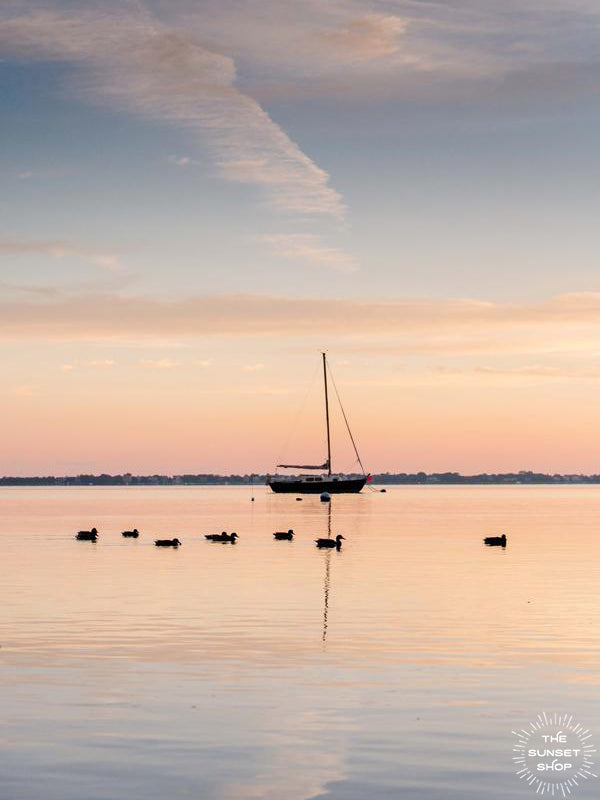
(0, 293, 600, 354)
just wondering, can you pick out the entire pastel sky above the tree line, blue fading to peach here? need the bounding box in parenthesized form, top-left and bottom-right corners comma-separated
(0, 0, 600, 475)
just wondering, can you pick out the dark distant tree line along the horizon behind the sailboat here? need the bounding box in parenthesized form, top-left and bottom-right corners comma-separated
(0, 470, 600, 486)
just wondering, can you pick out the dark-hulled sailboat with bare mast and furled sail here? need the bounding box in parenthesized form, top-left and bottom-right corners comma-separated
(267, 353, 371, 494)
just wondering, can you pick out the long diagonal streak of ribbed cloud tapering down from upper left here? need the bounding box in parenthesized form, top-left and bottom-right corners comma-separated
(0, 10, 345, 218)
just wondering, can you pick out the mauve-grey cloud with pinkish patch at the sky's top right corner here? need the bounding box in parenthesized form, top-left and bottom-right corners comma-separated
(168, 0, 600, 108)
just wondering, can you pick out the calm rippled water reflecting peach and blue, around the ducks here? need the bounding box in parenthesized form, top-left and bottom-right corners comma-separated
(0, 486, 600, 800)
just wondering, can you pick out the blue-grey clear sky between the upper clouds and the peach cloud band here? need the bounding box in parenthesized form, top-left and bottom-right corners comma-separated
(1, 37, 599, 299)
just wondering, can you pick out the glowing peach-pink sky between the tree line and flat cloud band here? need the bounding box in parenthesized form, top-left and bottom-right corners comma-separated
(3, 338, 600, 475)
